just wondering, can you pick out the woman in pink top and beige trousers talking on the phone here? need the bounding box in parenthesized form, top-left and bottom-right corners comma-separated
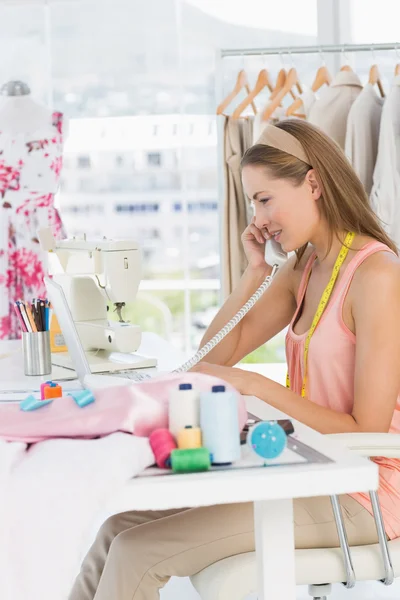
(70, 120, 400, 600)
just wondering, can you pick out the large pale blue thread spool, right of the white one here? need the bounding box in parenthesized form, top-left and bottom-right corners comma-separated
(200, 385, 240, 465)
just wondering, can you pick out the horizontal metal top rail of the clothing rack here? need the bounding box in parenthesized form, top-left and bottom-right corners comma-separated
(220, 42, 400, 58)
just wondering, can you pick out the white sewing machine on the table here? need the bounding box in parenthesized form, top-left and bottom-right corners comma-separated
(39, 228, 156, 373)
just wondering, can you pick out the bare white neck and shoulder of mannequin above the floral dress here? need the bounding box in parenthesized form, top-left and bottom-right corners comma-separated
(0, 81, 52, 135)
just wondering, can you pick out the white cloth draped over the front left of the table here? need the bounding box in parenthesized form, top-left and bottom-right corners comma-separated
(0, 433, 154, 600)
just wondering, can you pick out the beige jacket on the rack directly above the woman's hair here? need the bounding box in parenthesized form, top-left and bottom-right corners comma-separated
(308, 71, 362, 149)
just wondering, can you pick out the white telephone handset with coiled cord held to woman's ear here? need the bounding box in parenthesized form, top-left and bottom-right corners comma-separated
(174, 238, 288, 373)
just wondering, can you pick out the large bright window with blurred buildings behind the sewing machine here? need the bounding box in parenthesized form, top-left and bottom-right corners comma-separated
(4, 0, 318, 351)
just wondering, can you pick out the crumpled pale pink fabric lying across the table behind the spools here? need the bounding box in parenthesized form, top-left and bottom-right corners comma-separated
(0, 373, 247, 442)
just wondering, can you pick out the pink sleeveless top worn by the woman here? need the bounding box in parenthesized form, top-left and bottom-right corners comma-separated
(286, 242, 400, 539)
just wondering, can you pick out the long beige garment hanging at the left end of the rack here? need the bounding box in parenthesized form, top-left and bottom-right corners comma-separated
(222, 117, 253, 297)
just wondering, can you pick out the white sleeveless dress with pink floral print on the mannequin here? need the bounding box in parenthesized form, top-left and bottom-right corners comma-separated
(0, 112, 65, 339)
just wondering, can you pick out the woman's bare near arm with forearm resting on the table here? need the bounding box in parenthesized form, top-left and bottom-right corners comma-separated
(196, 253, 400, 433)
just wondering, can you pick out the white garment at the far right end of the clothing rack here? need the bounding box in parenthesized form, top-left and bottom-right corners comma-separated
(370, 76, 400, 248)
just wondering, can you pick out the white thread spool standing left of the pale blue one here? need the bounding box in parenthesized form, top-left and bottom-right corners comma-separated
(168, 383, 200, 437)
